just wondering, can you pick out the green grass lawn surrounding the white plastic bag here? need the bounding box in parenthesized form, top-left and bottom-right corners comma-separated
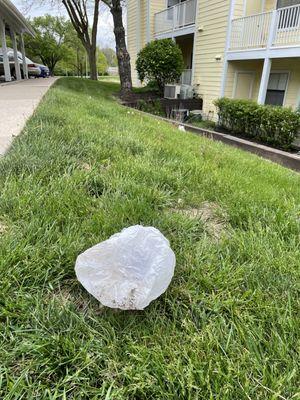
(0, 78, 300, 400)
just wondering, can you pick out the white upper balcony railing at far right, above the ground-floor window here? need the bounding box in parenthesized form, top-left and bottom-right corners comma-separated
(229, 5, 300, 50)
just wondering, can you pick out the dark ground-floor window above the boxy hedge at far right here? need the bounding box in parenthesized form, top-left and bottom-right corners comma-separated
(265, 72, 289, 106)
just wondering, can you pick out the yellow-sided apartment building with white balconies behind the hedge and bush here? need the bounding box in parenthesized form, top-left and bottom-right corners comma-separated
(127, 0, 300, 118)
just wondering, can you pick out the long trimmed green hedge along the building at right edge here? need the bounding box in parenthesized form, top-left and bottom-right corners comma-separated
(214, 98, 300, 149)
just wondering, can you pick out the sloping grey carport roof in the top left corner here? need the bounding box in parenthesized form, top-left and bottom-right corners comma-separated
(0, 0, 34, 35)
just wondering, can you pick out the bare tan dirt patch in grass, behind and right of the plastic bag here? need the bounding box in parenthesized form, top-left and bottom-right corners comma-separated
(176, 201, 228, 240)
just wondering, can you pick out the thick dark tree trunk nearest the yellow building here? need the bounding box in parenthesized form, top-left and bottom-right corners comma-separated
(110, 0, 132, 96)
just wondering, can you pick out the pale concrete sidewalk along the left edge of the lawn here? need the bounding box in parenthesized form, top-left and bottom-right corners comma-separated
(0, 78, 56, 155)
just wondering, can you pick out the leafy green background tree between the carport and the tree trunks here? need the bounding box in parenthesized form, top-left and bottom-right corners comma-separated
(25, 15, 73, 73)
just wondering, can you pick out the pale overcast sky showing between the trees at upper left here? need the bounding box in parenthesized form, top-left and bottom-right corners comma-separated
(13, 0, 115, 49)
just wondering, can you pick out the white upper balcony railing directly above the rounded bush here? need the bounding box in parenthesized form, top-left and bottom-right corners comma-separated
(154, 0, 197, 35)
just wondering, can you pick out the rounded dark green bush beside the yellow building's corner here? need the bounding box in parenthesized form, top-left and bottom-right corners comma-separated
(136, 39, 184, 92)
